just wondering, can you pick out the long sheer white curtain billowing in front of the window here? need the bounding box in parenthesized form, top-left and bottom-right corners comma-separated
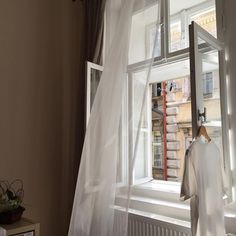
(68, 0, 158, 236)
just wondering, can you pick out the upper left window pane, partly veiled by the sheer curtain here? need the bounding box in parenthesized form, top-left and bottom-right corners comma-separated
(129, 0, 164, 64)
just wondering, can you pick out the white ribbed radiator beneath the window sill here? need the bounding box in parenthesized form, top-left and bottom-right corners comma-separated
(128, 214, 191, 236)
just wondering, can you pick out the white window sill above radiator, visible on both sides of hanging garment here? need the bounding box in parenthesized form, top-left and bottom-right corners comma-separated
(117, 180, 236, 232)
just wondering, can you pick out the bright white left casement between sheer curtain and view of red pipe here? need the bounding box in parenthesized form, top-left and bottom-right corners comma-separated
(128, 69, 152, 184)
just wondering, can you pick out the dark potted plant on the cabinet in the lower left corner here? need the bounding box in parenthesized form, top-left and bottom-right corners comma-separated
(0, 179, 25, 224)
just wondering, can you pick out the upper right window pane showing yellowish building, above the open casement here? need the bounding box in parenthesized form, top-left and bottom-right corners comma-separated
(169, 0, 216, 52)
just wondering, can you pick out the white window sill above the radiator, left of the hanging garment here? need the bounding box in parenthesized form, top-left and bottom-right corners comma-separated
(116, 180, 190, 222)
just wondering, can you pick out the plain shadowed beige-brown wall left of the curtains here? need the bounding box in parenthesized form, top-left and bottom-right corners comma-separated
(0, 0, 84, 236)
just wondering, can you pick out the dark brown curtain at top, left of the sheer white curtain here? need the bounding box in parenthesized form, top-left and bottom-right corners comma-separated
(84, 0, 106, 65)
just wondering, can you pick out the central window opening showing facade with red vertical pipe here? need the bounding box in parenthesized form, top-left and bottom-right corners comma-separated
(151, 60, 192, 181)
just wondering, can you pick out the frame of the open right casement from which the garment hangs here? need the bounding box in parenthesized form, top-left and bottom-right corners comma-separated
(190, 22, 232, 202)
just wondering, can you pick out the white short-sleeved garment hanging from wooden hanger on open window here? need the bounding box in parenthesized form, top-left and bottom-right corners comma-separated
(181, 138, 225, 236)
